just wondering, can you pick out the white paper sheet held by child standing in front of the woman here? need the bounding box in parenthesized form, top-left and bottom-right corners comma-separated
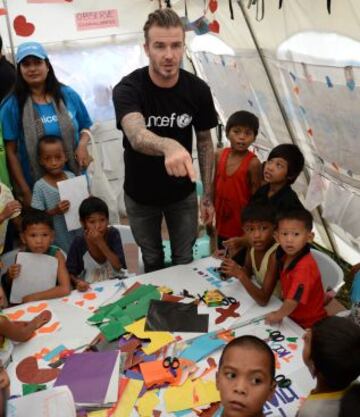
(57, 175, 89, 231)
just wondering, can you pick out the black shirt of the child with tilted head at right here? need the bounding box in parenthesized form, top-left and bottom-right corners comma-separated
(249, 184, 304, 214)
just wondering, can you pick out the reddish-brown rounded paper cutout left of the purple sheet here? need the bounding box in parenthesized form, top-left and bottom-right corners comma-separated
(16, 356, 59, 384)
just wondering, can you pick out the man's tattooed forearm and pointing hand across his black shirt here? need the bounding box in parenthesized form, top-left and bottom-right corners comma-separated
(121, 112, 195, 182)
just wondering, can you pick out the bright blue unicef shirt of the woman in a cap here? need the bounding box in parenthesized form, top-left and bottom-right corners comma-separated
(0, 86, 92, 188)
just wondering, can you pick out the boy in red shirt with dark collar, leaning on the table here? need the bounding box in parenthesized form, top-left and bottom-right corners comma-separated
(266, 209, 327, 328)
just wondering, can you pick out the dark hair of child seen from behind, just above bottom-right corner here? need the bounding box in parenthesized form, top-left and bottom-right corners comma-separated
(310, 316, 360, 390)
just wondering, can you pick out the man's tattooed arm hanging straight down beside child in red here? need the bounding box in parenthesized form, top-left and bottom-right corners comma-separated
(196, 130, 214, 224)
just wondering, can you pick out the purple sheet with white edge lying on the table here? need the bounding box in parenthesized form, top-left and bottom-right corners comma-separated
(54, 351, 120, 406)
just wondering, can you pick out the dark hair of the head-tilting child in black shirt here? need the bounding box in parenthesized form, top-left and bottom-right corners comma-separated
(267, 143, 305, 184)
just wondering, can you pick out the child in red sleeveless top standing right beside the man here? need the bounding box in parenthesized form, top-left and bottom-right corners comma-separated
(214, 110, 261, 247)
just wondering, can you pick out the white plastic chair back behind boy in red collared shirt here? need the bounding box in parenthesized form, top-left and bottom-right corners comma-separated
(311, 249, 344, 292)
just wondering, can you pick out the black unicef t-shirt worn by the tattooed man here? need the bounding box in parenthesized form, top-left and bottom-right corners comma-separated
(113, 67, 217, 205)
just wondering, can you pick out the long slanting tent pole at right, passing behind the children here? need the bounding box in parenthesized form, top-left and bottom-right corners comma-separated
(237, 0, 339, 259)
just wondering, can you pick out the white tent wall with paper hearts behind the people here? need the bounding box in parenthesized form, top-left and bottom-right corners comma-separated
(0, 0, 360, 263)
